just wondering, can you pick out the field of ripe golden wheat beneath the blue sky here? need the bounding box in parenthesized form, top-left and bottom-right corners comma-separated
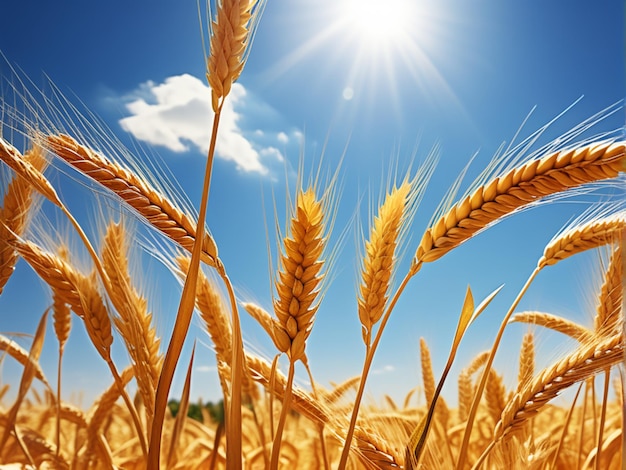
(0, 0, 626, 470)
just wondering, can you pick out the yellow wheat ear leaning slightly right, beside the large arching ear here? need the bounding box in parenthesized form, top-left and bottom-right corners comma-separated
(358, 180, 414, 345)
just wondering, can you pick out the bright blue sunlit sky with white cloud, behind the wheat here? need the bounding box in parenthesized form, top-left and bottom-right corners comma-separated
(0, 0, 624, 406)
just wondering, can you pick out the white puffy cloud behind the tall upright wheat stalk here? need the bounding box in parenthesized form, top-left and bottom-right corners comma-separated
(120, 74, 286, 174)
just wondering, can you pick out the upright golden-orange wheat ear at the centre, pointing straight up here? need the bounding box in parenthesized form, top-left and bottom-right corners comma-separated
(274, 189, 325, 362)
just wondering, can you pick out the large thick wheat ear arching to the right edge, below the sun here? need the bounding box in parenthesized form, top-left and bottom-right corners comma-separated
(415, 142, 625, 265)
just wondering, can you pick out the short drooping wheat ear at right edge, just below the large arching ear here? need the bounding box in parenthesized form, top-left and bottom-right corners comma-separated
(538, 211, 626, 269)
